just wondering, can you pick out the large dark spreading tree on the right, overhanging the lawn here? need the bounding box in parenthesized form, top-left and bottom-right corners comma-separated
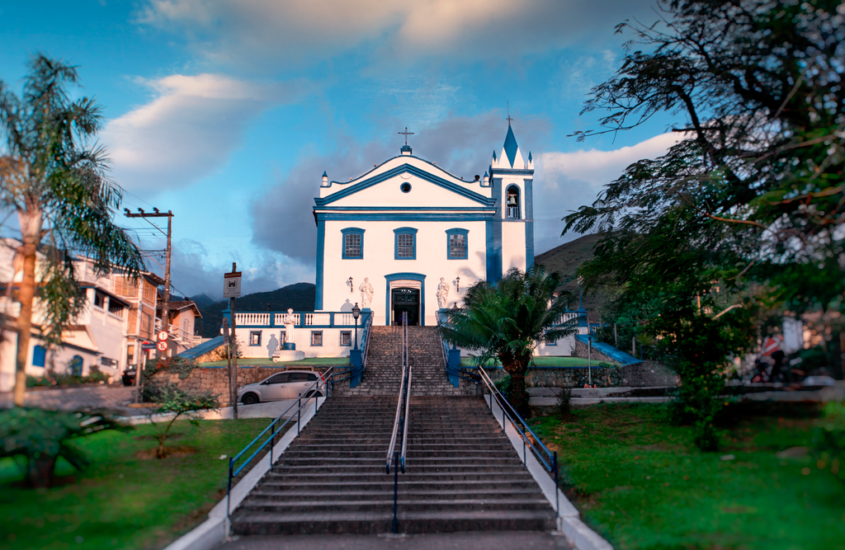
(564, 0, 845, 448)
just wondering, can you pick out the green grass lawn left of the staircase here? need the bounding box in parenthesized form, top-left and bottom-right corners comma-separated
(0, 418, 268, 550)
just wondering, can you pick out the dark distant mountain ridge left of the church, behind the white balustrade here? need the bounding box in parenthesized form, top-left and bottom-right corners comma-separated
(194, 283, 317, 338)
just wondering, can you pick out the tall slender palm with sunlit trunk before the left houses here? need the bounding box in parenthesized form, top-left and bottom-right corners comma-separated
(0, 54, 144, 406)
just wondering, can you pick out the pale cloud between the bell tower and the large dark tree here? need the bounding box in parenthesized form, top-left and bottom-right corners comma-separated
(534, 133, 682, 253)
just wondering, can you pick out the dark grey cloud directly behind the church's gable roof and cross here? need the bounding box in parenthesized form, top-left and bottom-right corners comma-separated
(250, 111, 549, 261)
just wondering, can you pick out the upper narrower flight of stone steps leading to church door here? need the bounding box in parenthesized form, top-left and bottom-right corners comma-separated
(334, 326, 475, 397)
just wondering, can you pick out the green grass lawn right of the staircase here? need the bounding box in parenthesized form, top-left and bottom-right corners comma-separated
(531, 404, 845, 550)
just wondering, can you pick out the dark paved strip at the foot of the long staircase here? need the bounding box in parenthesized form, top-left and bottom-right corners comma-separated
(219, 531, 571, 550)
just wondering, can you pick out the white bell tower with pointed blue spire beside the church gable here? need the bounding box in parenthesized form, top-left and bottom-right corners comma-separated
(488, 123, 534, 282)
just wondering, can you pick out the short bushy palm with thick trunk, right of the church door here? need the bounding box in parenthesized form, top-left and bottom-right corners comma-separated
(441, 266, 577, 413)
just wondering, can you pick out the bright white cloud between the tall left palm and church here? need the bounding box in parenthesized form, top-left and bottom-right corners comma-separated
(102, 74, 314, 193)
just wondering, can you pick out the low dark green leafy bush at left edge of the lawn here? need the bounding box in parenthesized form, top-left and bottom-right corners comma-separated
(0, 407, 131, 487)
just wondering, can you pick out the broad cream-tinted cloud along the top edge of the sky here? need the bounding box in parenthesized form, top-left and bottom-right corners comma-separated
(136, 0, 654, 66)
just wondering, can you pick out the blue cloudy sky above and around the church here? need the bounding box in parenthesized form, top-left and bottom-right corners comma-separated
(0, 0, 676, 299)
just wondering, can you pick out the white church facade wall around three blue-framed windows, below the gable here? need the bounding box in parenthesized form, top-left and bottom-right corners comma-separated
(323, 221, 488, 326)
